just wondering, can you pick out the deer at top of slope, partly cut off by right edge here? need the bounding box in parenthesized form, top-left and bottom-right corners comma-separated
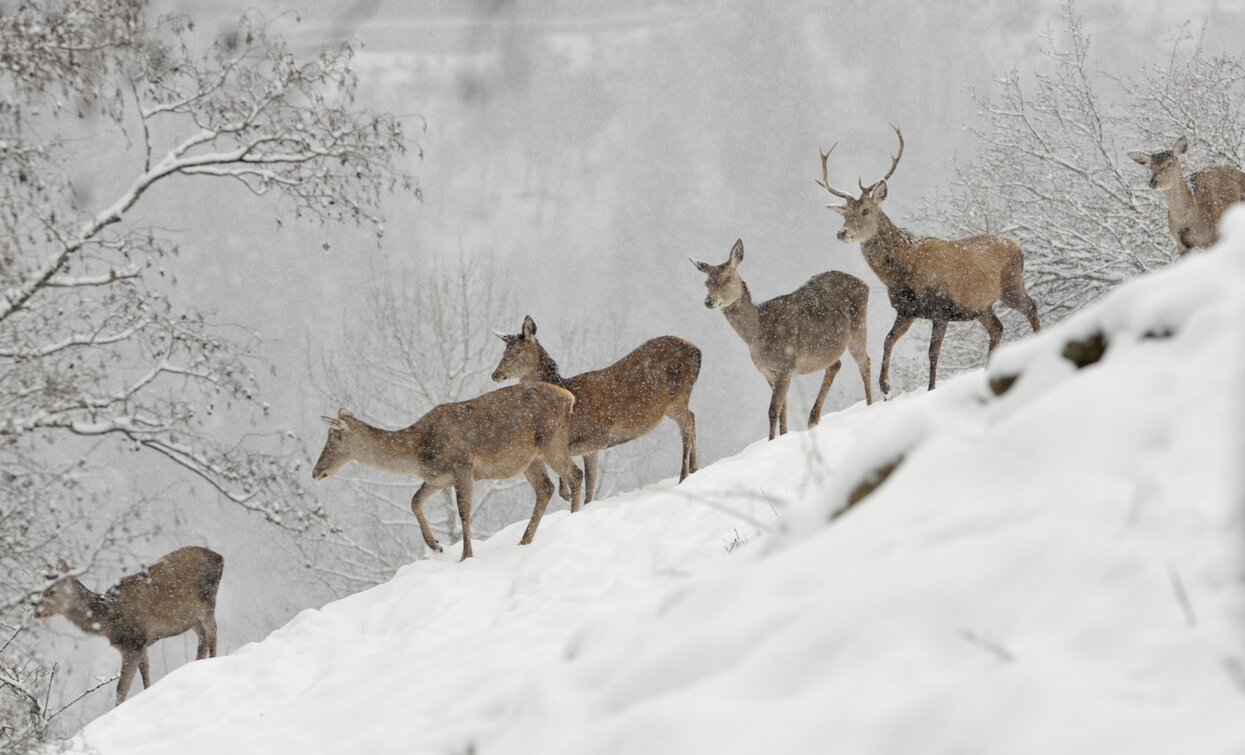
(1128, 136, 1245, 257)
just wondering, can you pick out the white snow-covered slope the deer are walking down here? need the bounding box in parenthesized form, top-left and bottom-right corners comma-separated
(76, 211, 1245, 755)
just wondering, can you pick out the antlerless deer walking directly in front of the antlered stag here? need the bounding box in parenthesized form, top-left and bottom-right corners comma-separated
(691, 239, 873, 440)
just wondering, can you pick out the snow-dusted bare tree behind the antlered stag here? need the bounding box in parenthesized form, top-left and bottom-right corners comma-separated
(925, 1, 1245, 369)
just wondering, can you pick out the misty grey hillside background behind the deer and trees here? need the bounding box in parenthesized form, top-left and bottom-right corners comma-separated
(14, 0, 1245, 732)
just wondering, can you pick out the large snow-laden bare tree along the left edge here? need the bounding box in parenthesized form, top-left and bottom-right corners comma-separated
(0, 0, 417, 737)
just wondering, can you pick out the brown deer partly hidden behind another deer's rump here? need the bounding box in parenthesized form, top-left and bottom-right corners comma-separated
(493, 315, 701, 505)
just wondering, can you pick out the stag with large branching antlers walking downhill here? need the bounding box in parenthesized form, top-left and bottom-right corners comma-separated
(817, 126, 1042, 395)
